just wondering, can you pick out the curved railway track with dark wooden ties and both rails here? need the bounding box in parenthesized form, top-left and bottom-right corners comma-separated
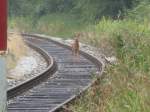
(7, 34, 103, 112)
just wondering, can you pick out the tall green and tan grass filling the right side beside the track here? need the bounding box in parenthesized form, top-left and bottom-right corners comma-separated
(70, 19, 150, 112)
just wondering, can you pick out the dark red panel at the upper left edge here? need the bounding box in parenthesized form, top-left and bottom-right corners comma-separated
(0, 0, 7, 51)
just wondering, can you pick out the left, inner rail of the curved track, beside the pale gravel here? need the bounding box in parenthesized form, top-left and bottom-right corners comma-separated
(7, 41, 57, 100)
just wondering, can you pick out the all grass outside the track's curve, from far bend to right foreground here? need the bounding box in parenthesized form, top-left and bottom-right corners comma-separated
(9, 14, 150, 112)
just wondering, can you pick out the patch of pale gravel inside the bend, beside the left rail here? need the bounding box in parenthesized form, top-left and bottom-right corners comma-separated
(7, 48, 47, 88)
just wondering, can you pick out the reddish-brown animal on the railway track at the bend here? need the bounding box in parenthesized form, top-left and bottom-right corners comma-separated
(71, 33, 80, 56)
